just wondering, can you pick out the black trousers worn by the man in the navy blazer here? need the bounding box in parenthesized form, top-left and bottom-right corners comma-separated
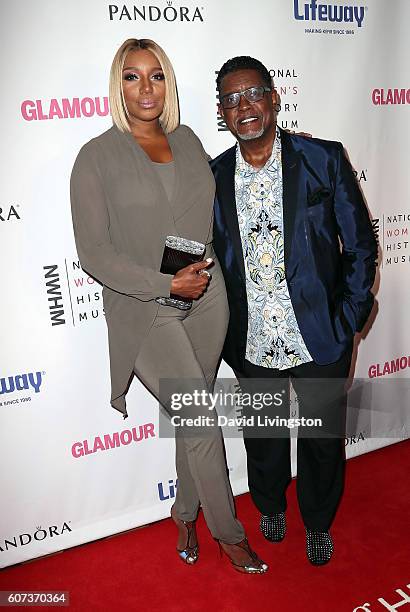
(235, 348, 352, 531)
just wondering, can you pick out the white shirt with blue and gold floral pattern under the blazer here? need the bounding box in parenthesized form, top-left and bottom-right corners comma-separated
(235, 130, 312, 370)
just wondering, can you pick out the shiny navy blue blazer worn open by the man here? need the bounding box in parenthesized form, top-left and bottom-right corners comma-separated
(211, 130, 377, 372)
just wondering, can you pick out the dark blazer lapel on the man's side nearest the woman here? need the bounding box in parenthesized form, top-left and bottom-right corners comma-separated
(215, 146, 245, 279)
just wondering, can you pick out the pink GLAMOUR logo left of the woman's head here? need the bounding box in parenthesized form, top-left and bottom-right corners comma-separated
(21, 96, 110, 121)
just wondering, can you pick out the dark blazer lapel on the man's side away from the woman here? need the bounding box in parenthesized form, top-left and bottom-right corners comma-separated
(280, 129, 300, 270)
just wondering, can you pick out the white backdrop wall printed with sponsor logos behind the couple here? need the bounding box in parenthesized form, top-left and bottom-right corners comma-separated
(0, 0, 410, 567)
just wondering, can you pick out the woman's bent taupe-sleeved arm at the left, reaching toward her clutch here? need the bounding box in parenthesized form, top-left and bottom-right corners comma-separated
(70, 148, 173, 301)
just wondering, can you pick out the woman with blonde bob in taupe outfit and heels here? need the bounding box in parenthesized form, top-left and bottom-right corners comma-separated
(71, 39, 267, 573)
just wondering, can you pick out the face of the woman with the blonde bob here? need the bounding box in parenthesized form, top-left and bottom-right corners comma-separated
(122, 49, 165, 124)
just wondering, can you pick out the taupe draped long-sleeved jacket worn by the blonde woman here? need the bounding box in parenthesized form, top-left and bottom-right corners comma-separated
(71, 125, 215, 418)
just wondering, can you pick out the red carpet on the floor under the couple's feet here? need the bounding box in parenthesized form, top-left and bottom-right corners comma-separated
(0, 441, 410, 612)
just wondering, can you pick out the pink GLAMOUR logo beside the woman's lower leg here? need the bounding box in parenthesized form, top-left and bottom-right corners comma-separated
(71, 423, 155, 459)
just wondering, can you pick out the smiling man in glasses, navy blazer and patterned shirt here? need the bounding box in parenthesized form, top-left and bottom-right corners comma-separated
(211, 56, 377, 565)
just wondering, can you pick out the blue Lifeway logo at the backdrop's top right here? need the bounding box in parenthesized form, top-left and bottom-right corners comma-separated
(293, 0, 365, 28)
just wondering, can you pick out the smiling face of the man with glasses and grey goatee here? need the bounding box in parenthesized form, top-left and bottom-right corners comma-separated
(219, 70, 277, 140)
